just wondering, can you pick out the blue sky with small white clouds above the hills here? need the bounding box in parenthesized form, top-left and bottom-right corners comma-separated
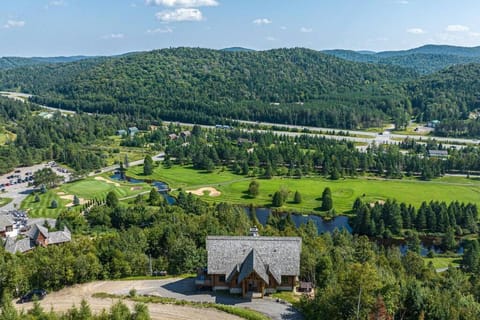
(0, 0, 480, 56)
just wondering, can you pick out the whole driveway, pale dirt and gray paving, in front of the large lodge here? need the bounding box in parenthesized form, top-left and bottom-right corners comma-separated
(16, 278, 302, 320)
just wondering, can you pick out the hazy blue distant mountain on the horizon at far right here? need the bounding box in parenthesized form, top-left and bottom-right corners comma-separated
(323, 45, 480, 74)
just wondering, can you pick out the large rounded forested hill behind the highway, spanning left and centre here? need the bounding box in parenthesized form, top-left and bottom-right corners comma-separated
(0, 48, 415, 128)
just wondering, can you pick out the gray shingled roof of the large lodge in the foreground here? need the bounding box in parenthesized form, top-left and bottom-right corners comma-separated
(207, 236, 302, 283)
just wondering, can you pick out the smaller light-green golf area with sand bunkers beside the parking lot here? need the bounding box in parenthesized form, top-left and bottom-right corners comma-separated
(20, 178, 151, 218)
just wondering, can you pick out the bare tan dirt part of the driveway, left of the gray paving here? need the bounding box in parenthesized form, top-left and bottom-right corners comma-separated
(16, 281, 241, 320)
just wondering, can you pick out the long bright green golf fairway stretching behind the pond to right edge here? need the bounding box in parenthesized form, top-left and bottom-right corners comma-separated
(128, 166, 480, 213)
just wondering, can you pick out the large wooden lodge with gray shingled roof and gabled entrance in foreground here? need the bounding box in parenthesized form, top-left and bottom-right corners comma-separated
(195, 228, 302, 298)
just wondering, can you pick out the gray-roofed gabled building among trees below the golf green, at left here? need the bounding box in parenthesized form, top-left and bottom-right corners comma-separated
(5, 224, 72, 253)
